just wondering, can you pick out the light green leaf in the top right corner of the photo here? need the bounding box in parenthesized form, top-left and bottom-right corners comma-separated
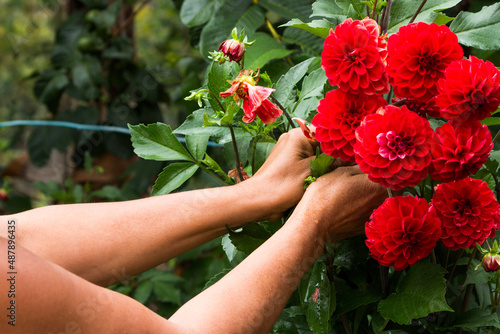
(450, 2, 500, 50)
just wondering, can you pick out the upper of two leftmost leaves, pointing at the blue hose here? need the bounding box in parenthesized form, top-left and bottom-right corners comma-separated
(128, 123, 193, 161)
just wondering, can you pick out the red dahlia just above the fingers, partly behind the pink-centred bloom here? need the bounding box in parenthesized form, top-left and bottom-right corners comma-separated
(312, 89, 387, 161)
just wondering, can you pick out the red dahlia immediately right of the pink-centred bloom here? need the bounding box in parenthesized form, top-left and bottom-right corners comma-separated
(429, 121, 493, 182)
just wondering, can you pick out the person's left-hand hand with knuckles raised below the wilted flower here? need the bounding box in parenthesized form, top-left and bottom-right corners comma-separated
(241, 129, 317, 221)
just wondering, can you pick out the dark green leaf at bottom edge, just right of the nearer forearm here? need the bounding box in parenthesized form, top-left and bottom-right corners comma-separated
(299, 260, 330, 334)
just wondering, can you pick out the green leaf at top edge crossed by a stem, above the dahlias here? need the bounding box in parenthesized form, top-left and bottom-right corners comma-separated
(388, 0, 460, 35)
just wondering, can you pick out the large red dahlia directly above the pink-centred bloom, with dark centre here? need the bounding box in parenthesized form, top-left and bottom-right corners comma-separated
(387, 22, 463, 102)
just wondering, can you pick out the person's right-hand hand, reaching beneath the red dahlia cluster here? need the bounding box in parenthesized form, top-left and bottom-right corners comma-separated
(295, 165, 387, 242)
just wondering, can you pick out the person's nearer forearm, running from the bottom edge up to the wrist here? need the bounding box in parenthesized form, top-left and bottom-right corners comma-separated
(169, 210, 323, 333)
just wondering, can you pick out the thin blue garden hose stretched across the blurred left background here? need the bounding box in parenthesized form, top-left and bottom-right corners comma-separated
(0, 120, 221, 147)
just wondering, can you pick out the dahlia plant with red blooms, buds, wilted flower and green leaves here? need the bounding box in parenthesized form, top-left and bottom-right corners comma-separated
(126, 0, 500, 333)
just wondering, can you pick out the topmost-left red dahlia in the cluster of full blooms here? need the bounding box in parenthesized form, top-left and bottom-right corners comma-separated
(321, 18, 390, 95)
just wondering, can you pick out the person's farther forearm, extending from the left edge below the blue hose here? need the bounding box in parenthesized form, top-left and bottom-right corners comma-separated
(0, 184, 274, 285)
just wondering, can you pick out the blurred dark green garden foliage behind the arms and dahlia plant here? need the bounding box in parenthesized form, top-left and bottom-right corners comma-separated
(0, 0, 500, 333)
